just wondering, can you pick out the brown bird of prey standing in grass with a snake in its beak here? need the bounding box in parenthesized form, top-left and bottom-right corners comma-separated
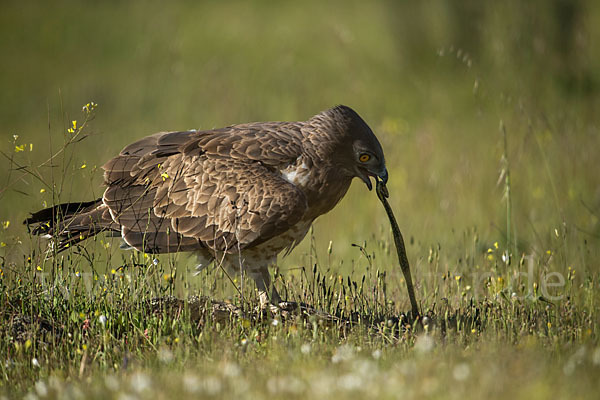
(25, 105, 388, 306)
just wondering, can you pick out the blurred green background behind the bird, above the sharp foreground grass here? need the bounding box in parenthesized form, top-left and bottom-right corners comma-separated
(0, 0, 600, 272)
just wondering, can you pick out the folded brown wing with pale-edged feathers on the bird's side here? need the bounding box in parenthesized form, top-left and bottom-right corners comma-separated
(103, 123, 308, 252)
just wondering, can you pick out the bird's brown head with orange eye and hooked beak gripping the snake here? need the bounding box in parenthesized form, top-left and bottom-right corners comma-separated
(326, 106, 388, 190)
